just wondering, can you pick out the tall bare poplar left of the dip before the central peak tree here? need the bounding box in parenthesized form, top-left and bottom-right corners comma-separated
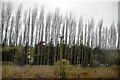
(36, 6, 44, 64)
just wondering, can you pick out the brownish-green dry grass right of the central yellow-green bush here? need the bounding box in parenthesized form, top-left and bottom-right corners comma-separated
(68, 66, 118, 78)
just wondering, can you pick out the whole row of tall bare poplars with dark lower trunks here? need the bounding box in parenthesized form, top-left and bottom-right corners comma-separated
(0, 3, 120, 66)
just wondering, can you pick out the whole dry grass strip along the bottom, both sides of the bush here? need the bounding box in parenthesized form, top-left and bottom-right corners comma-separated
(2, 65, 118, 78)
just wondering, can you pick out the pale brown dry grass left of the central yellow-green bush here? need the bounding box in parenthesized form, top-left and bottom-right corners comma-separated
(2, 65, 56, 78)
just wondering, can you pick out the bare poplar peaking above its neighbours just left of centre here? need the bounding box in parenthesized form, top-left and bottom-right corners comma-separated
(52, 8, 62, 61)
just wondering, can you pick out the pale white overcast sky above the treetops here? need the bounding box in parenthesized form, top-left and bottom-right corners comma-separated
(0, 0, 119, 26)
